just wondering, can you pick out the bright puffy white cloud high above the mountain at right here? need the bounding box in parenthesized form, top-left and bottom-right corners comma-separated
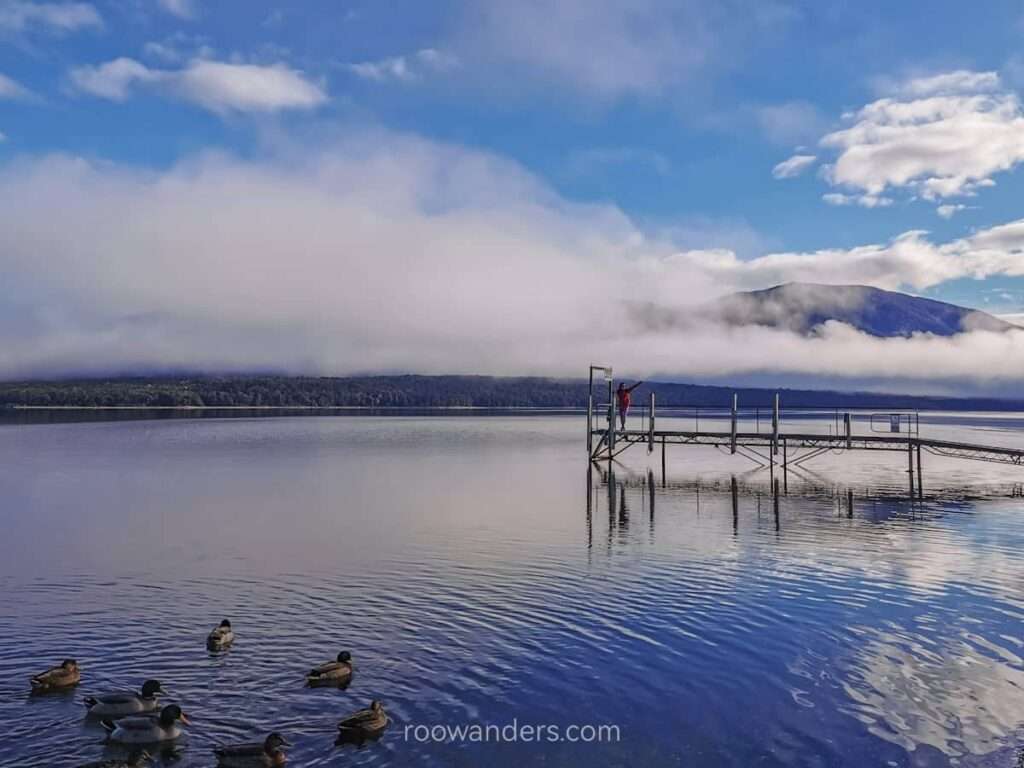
(820, 71, 1024, 210)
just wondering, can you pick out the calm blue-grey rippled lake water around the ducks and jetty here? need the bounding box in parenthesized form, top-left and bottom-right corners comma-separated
(0, 415, 1024, 768)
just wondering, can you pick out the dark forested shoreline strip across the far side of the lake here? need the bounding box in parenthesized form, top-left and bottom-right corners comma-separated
(0, 376, 1024, 411)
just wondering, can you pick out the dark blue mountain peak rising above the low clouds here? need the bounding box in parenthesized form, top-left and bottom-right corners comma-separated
(711, 283, 1018, 337)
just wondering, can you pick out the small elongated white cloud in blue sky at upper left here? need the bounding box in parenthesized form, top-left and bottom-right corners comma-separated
(70, 58, 327, 115)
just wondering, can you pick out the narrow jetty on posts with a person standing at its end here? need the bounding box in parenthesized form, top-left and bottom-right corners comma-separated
(587, 366, 1024, 493)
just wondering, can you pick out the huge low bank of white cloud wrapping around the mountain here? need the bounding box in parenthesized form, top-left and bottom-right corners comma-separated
(0, 132, 1024, 387)
